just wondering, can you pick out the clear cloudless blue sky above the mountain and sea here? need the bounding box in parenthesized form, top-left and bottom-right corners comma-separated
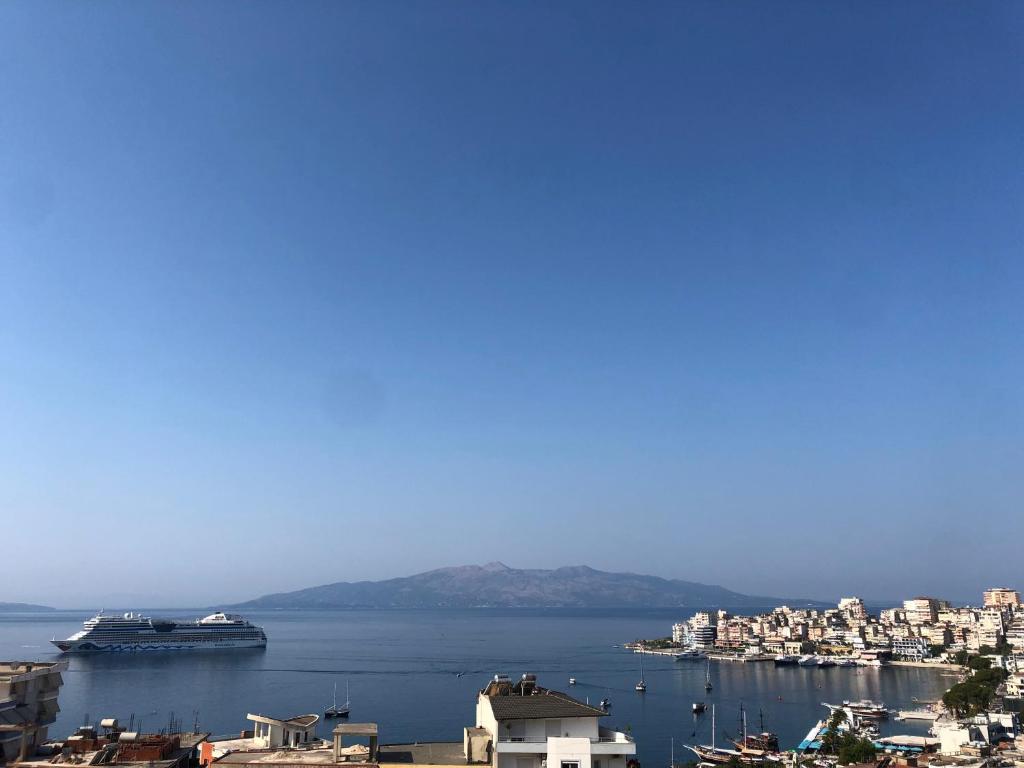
(0, 0, 1024, 607)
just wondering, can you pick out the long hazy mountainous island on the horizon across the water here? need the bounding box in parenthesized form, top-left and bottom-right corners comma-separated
(230, 562, 821, 610)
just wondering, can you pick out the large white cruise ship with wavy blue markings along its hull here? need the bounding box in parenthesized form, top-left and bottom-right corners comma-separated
(51, 611, 266, 653)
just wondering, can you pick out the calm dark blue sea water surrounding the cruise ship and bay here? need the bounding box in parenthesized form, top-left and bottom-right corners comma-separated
(0, 609, 953, 767)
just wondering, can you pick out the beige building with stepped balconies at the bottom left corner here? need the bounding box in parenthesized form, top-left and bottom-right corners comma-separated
(0, 662, 68, 763)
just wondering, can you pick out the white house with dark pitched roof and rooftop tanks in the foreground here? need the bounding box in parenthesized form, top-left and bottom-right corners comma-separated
(476, 675, 636, 768)
